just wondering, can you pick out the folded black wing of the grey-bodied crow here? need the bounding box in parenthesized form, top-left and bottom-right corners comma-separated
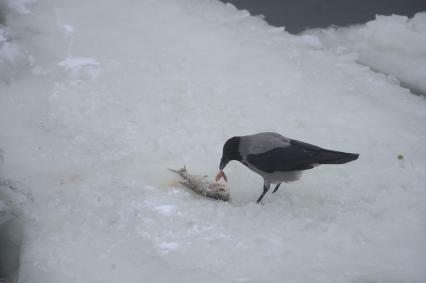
(247, 140, 353, 173)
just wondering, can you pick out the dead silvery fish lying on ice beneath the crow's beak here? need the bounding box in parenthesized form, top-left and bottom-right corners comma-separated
(169, 167, 231, 201)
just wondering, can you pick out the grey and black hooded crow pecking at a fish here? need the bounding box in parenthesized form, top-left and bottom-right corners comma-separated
(216, 133, 359, 203)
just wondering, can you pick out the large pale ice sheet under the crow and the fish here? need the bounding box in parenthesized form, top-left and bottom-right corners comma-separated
(0, 0, 426, 283)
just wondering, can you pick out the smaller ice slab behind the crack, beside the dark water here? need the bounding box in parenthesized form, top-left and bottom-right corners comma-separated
(305, 12, 426, 95)
